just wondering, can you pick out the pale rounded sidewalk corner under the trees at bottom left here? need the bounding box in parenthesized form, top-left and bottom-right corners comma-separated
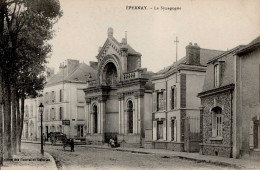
(1, 147, 58, 170)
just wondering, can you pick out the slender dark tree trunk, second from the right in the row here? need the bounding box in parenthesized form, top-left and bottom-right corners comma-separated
(16, 91, 21, 152)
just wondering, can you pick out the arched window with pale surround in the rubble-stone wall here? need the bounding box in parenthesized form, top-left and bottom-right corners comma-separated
(211, 106, 223, 137)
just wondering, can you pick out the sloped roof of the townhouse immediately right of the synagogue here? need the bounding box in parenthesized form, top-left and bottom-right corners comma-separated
(156, 48, 224, 74)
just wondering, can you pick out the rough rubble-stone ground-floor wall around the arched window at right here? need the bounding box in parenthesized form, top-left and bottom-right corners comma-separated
(201, 91, 233, 157)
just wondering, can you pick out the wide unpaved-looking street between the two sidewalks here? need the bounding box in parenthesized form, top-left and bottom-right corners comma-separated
(23, 143, 235, 170)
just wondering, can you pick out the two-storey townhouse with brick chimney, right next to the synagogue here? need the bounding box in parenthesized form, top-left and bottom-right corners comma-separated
(150, 43, 223, 152)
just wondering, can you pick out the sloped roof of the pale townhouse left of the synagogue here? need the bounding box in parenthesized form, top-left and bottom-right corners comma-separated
(46, 63, 97, 86)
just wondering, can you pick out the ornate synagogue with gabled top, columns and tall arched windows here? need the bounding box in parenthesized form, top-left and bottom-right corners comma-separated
(84, 28, 152, 147)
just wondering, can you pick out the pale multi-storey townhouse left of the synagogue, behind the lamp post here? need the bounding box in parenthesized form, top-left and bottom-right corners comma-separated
(23, 59, 96, 140)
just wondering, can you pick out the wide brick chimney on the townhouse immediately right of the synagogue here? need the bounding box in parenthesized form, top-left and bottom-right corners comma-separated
(186, 42, 200, 65)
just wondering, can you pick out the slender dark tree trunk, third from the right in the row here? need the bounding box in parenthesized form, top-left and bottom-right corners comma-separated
(11, 85, 17, 154)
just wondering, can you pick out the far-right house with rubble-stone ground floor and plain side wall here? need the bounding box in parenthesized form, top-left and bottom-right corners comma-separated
(198, 37, 260, 158)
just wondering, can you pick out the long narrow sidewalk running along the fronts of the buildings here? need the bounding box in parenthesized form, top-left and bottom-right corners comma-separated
(78, 145, 260, 169)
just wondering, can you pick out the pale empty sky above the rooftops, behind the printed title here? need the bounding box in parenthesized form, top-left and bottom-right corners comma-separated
(48, 0, 260, 72)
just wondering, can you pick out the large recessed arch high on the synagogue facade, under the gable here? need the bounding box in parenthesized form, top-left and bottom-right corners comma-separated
(103, 62, 118, 86)
